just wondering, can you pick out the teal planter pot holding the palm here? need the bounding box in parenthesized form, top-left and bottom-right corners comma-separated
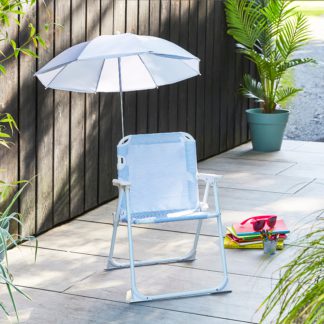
(246, 108, 289, 152)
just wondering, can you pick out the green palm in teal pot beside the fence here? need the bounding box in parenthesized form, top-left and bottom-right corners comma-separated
(225, 0, 315, 152)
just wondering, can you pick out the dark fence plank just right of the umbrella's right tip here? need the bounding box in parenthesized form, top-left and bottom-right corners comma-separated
(204, 0, 215, 158)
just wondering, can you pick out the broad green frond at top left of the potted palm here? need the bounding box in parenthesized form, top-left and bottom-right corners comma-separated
(225, 0, 265, 48)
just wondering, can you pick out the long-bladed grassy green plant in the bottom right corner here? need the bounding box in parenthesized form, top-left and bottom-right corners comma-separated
(260, 219, 324, 324)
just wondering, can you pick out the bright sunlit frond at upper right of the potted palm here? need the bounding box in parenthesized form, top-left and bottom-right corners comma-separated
(276, 13, 310, 59)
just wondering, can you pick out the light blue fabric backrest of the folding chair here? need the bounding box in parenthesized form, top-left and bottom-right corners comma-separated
(117, 132, 199, 217)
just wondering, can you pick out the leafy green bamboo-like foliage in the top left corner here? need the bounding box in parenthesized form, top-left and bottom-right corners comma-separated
(0, 0, 49, 75)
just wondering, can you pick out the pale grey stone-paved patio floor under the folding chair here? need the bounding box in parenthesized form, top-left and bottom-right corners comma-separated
(0, 141, 324, 324)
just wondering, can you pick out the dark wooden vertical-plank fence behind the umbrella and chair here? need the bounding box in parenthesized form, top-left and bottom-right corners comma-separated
(0, 0, 250, 234)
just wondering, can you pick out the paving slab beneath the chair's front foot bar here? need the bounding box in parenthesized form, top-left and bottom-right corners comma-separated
(67, 265, 276, 322)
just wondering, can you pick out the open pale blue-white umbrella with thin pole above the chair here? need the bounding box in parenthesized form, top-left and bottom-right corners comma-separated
(35, 34, 200, 135)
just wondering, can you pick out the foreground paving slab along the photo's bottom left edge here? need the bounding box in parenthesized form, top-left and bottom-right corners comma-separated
(0, 288, 237, 324)
